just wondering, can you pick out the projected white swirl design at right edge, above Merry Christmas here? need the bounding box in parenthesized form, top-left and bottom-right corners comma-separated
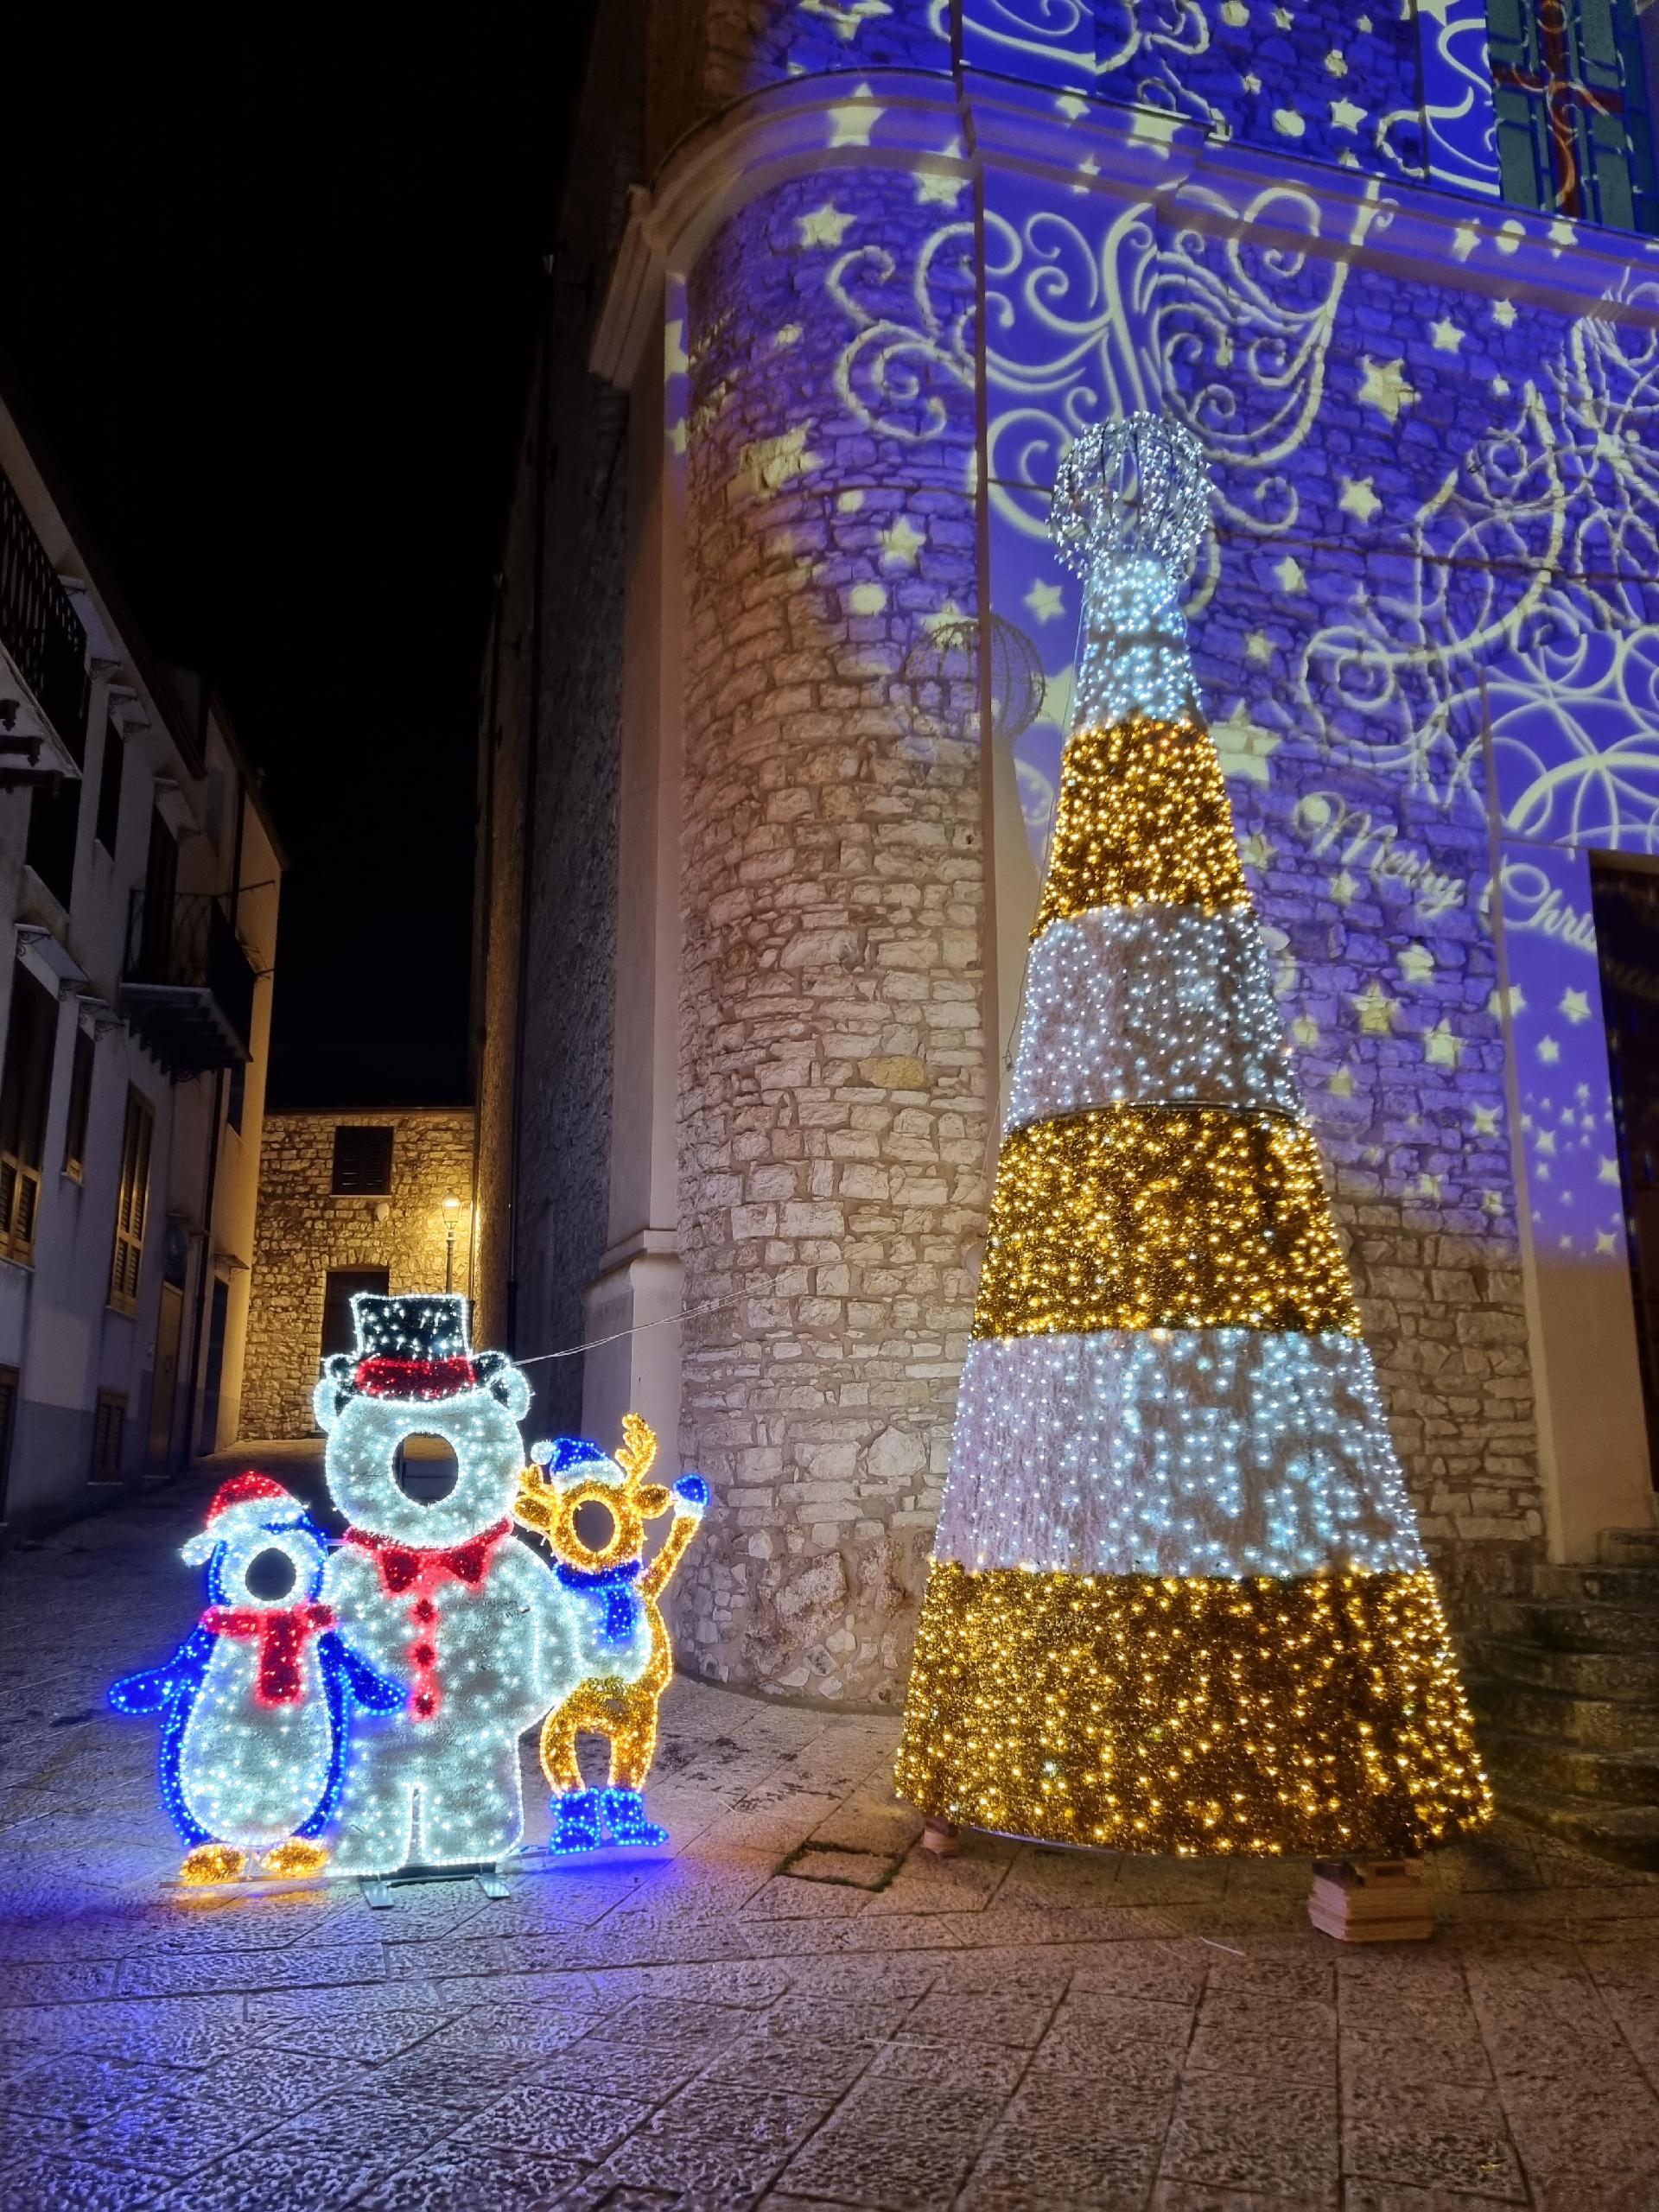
(1300, 285, 1659, 818)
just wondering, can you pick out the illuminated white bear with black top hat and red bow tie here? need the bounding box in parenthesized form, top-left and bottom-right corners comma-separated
(315, 1294, 584, 1873)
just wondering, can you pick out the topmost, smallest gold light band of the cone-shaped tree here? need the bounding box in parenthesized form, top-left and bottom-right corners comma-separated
(1031, 715, 1249, 938)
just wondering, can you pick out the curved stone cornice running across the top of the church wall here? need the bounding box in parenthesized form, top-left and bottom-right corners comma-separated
(591, 71, 1659, 387)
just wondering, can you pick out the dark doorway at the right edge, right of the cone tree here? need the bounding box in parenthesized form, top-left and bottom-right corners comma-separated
(1591, 854, 1659, 1489)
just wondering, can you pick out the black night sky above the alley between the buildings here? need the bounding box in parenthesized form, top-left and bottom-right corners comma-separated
(0, 23, 588, 1106)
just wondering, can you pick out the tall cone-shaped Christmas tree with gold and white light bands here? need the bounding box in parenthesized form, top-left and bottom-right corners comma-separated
(898, 416, 1491, 1858)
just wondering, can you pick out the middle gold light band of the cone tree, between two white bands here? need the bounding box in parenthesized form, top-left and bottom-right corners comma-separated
(973, 1106, 1360, 1336)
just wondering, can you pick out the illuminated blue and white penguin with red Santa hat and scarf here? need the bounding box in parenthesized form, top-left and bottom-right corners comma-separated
(111, 1473, 403, 1885)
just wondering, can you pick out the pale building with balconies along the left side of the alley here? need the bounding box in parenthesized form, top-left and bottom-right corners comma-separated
(0, 380, 283, 1529)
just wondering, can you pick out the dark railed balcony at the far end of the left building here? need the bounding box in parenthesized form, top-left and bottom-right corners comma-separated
(118, 892, 254, 1084)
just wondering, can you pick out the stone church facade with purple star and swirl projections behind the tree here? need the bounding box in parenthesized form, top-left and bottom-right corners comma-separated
(478, 0, 1659, 1703)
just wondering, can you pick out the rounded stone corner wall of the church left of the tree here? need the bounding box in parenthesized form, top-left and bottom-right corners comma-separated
(675, 173, 988, 1701)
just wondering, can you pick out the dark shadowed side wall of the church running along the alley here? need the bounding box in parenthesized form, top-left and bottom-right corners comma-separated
(474, 0, 645, 1431)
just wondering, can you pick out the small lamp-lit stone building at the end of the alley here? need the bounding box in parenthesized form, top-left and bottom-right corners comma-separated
(238, 1109, 475, 1438)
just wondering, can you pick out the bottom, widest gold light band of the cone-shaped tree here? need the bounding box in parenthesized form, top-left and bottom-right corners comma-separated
(896, 1564, 1493, 1858)
